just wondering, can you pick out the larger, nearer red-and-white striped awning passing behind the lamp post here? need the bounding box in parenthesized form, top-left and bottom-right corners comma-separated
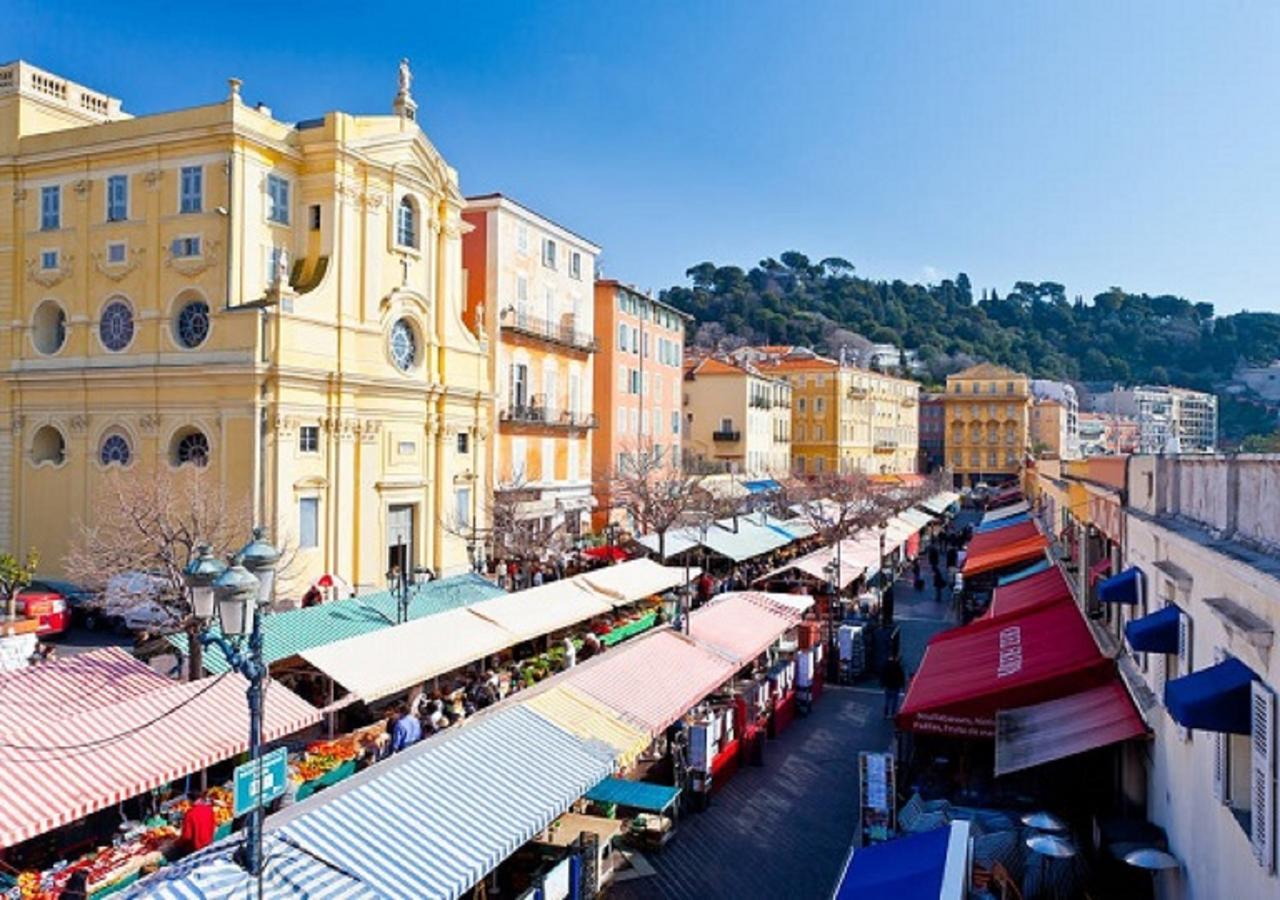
(0, 668, 320, 848)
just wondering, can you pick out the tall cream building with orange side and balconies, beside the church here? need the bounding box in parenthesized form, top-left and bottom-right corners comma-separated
(458, 193, 600, 533)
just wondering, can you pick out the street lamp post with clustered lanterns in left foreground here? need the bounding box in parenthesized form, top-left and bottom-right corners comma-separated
(183, 527, 280, 896)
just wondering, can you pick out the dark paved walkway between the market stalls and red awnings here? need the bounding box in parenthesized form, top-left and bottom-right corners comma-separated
(613, 553, 950, 900)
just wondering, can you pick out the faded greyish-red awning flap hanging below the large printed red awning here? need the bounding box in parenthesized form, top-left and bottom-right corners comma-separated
(996, 676, 1147, 777)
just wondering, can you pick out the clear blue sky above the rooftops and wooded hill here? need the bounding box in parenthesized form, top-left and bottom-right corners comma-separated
(12, 0, 1280, 311)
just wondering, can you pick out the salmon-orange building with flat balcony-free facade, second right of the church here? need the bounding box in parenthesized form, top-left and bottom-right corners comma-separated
(591, 279, 689, 527)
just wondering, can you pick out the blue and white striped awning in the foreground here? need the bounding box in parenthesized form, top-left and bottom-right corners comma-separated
(132, 707, 616, 900)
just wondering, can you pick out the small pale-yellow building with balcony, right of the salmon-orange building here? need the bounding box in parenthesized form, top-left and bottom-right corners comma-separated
(684, 356, 791, 478)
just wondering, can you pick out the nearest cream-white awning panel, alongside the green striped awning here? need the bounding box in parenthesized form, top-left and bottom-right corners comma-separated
(300, 611, 522, 702)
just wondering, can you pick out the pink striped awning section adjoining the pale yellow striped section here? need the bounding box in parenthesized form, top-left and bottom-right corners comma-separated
(563, 631, 737, 735)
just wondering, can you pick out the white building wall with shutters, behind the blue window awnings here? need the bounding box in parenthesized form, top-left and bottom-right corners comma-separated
(1124, 457, 1280, 900)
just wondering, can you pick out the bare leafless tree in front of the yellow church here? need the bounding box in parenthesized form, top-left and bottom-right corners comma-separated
(64, 466, 279, 679)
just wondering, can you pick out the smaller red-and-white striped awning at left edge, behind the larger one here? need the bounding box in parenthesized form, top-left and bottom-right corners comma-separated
(0, 647, 173, 732)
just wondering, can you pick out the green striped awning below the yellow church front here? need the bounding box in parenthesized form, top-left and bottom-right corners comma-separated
(168, 572, 507, 675)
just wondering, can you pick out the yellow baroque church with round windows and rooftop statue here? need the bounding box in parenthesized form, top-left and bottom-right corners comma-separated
(0, 61, 493, 591)
